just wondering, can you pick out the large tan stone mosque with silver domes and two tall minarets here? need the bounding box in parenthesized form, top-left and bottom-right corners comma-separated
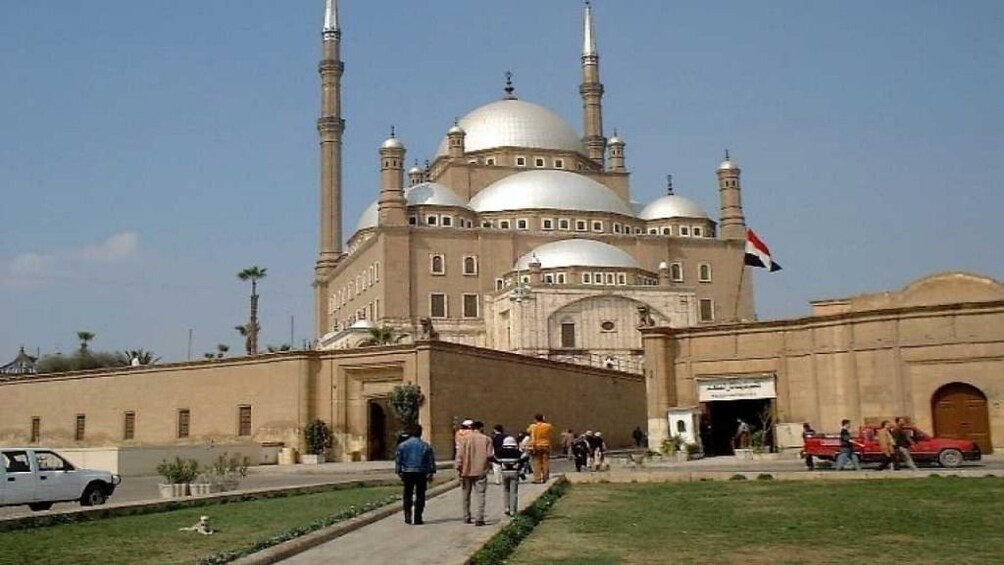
(314, 0, 755, 371)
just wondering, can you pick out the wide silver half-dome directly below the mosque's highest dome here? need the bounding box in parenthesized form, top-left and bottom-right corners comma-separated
(470, 170, 635, 216)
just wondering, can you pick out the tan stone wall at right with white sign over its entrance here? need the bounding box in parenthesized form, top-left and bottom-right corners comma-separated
(643, 273, 1004, 451)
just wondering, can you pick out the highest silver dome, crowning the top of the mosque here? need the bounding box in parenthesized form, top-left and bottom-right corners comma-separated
(437, 99, 585, 156)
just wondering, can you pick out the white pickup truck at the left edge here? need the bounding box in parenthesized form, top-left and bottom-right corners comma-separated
(0, 448, 121, 510)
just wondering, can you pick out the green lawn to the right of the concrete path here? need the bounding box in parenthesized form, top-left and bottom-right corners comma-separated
(508, 478, 1004, 565)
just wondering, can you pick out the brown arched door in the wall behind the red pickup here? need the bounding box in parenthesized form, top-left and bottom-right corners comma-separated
(931, 382, 993, 454)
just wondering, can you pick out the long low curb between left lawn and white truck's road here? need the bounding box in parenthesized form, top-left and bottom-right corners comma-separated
(0, 479, 400, 532)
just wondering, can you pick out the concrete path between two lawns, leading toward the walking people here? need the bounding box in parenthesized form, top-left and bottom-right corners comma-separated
(282, 479, 554, 565)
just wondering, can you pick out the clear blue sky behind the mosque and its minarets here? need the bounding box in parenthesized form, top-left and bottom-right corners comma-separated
(0, 0, 1004, 361)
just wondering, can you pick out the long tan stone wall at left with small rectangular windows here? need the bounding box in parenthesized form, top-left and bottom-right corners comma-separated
(0, 341, 645, 461)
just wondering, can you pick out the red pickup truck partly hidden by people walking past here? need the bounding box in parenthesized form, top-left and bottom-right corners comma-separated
(802, 426, 983, 468)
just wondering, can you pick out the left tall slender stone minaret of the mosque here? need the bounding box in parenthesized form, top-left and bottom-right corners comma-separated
(314, 0, 345, 337)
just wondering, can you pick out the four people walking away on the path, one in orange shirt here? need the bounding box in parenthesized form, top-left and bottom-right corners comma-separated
(395, 413, 552, 526)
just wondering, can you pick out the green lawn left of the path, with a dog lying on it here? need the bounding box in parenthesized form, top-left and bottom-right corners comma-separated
(0, 487, 401, 564)
